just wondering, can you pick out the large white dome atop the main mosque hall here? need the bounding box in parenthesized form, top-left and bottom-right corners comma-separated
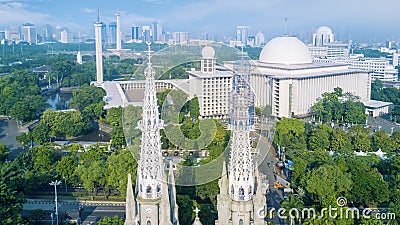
(259, 37, 313, 65)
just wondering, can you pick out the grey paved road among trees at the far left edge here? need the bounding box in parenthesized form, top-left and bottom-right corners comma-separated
(0, 117, 22, 160)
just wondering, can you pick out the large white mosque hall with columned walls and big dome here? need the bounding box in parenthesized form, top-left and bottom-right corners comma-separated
(225, 37, 371, 117)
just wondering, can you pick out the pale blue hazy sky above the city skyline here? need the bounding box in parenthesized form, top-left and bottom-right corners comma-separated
(0, 0, 400, 41)
